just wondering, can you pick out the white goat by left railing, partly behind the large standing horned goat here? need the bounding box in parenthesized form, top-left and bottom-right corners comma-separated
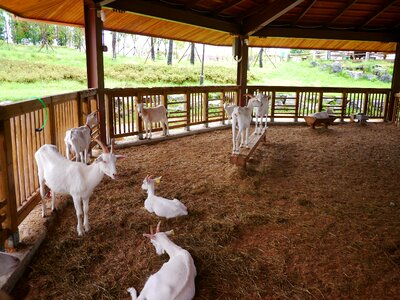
(64, 111, 98, 164)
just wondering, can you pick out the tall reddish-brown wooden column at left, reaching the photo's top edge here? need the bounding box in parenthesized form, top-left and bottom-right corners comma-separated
(84, 0, 107, 143)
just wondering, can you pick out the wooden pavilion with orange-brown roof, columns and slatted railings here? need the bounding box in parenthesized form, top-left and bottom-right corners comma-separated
(0, 0, 400, 247)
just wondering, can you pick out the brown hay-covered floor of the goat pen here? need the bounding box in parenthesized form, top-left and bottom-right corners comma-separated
(10, 123, 400, 299)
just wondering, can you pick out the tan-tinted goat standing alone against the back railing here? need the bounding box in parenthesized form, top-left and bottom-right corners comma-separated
(137, 103, 169, 139)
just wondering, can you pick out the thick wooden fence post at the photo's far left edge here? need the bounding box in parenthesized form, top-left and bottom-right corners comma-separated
(0, 119, 19, 247)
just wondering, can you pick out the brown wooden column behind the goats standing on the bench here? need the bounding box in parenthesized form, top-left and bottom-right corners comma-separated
(236, 37, 249, 106)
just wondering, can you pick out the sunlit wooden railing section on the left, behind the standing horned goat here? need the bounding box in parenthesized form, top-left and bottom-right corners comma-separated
(0, 90, 97, 248)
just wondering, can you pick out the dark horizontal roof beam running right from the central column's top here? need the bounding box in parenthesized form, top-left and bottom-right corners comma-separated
(257, 27, 400, 42)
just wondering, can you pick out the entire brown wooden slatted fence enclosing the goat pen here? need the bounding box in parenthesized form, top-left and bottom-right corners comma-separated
(0, 86, 400, 248)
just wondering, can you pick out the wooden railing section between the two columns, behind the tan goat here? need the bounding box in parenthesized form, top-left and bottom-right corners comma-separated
(105, 86, 238, 138)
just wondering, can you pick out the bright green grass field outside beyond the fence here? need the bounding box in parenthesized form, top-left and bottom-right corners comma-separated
(0, 43, 393, 101)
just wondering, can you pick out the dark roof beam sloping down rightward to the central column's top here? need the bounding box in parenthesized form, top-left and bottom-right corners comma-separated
(106, 0, 240, 34)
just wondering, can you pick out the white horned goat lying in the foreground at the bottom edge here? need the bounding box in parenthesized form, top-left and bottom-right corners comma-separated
(128, 223, 197, 300)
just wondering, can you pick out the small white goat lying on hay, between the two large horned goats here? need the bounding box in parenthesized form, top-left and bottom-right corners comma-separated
(142, 176, 188, 219)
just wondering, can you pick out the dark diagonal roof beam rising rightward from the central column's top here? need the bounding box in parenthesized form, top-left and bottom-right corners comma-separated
(243, 0, 304, 35)
